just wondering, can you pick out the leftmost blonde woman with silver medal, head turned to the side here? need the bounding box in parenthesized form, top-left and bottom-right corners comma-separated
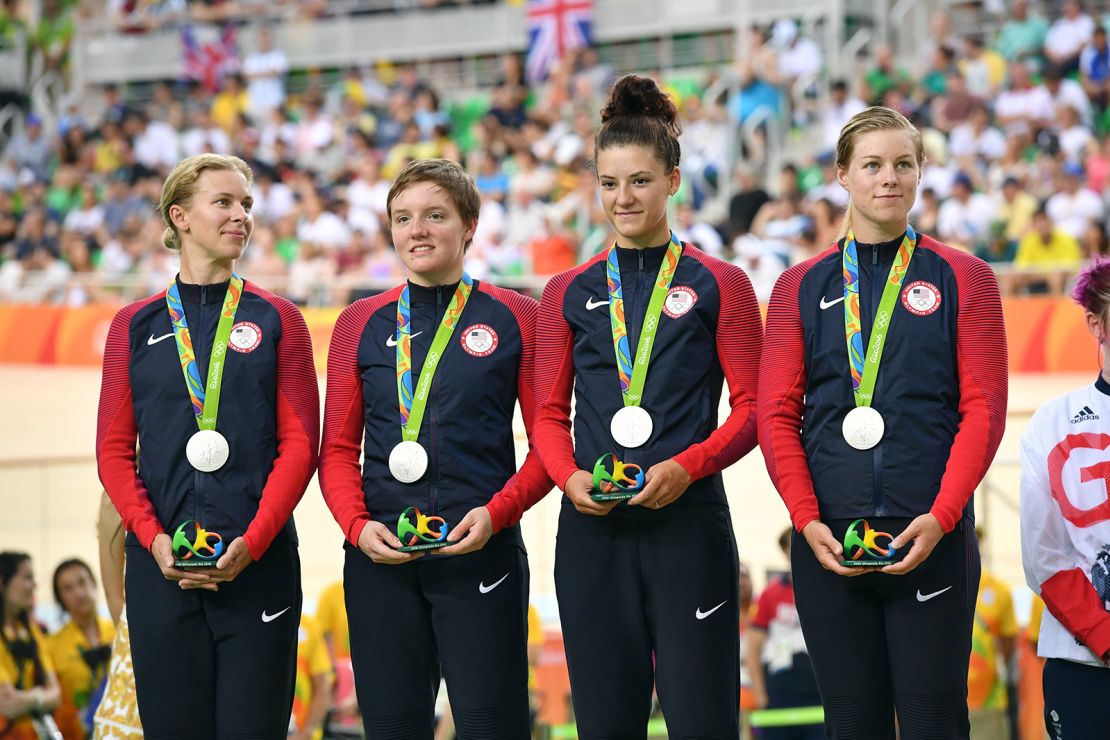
(97, 154, 320, 738)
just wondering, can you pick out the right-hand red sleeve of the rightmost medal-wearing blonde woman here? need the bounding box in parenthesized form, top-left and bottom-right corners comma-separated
(926, 237, 1008, 531)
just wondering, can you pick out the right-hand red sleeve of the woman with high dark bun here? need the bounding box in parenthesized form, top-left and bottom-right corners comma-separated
(675, 250, 763, 480)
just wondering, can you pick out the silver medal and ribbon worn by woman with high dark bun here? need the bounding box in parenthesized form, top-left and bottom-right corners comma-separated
(605, 233, 683, 448)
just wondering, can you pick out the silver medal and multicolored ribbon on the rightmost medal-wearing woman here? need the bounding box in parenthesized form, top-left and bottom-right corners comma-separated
(841, 225, 917, 449)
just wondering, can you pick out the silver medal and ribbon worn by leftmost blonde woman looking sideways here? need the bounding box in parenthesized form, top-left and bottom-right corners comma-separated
(165, 273, 243, 473)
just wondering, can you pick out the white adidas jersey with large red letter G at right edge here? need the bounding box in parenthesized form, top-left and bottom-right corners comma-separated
(1021, 377, 1110, 666)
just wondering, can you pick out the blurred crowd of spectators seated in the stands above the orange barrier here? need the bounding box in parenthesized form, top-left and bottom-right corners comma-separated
(0, 0, 1110, 305)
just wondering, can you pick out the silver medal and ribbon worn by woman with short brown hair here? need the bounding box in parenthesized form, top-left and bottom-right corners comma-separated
(390, 272, 473, 483)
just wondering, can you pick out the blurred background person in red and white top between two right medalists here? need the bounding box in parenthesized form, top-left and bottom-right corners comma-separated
(745, 528, 825, 740)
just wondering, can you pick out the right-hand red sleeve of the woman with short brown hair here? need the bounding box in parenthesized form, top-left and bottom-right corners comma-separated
(478, 283, 554, 534)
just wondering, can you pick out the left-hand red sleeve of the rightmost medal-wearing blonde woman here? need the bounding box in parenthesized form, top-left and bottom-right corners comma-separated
(757, 257, 827, 531)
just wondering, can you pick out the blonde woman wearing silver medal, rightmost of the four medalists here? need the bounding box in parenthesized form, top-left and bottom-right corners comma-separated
(758, 107, 1007, 740)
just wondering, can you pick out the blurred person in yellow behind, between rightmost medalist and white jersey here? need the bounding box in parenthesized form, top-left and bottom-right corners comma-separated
(968, 527, 1018, 740)
